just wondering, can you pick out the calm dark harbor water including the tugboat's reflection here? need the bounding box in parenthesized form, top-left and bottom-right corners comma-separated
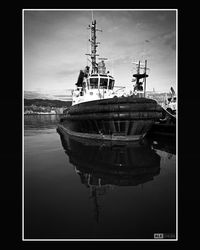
(23, 115, 177, 240)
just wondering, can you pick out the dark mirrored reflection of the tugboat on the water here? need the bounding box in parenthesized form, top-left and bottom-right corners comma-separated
(57, 129, 163, 222)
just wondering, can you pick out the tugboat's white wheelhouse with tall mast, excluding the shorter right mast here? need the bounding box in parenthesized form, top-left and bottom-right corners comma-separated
(72, 20, 115, 105)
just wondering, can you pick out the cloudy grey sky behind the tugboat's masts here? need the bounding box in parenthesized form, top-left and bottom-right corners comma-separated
(23, 9, 177, 99)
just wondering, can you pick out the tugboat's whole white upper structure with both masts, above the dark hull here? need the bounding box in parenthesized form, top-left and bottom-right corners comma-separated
(72, 20, 151, 105)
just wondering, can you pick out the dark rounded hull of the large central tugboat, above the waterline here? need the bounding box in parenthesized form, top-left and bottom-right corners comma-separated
(59, 97, 162, 141)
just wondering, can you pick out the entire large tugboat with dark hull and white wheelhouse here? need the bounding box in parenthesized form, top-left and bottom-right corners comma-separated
(58, 20, 162, 141)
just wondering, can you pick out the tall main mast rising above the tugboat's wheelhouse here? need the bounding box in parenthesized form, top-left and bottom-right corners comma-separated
(86, 20, 102, 73)
